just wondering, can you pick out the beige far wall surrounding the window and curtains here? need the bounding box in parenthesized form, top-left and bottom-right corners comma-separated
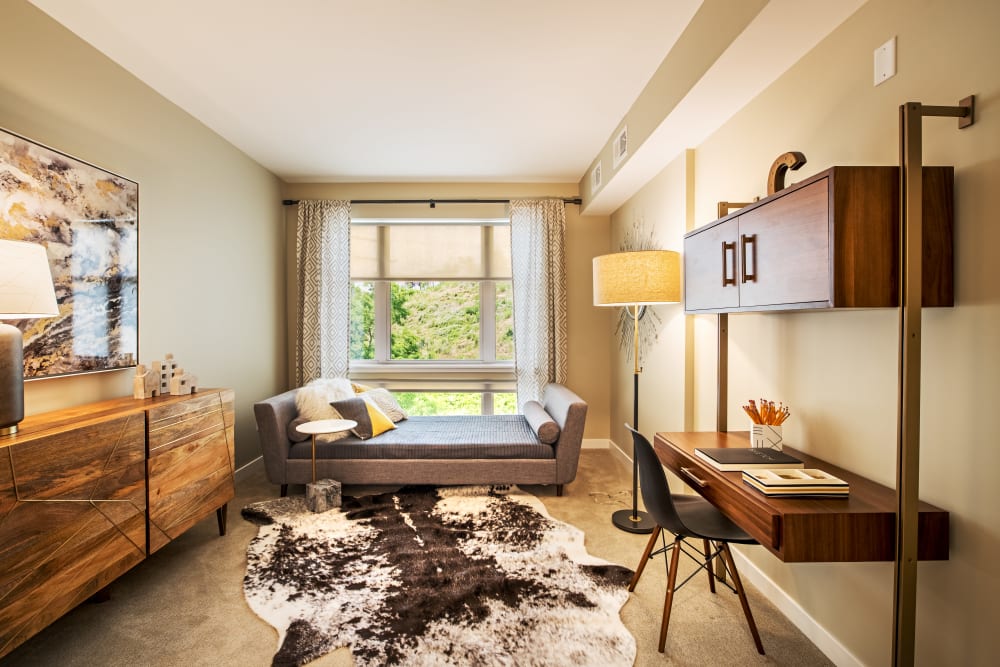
(283, 183, 613, 439)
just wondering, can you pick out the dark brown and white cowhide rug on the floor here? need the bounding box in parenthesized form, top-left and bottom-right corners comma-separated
(243, 487, 635, 667)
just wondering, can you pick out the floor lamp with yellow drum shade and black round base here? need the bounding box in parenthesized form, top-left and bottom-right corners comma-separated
(594, 250, 681, 533)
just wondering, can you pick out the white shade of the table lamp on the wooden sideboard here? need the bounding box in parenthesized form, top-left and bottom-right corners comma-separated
(0, 241, 59, 320)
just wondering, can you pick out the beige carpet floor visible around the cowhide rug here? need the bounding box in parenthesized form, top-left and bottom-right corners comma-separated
(0, 450, 831, 667)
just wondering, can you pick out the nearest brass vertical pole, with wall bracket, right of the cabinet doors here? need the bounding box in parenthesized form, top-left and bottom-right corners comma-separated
(892, 96, 975, 666)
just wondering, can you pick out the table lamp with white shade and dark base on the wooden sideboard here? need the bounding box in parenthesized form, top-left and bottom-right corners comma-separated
(0, 240, 59, 436)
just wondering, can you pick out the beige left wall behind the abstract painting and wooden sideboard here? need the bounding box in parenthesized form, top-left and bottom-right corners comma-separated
(0, 0, 286, 465)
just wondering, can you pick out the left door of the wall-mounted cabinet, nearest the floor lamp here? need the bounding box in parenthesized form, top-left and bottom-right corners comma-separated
(684, 218, 740, 311)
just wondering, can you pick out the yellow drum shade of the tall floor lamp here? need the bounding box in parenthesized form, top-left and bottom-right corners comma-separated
(594, 250, 681, 306)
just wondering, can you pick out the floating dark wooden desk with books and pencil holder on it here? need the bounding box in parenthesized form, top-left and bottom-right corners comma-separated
(653, 431, 948, 563)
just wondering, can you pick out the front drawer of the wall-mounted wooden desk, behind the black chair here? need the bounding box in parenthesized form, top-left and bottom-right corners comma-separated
(653, 434, 783, 558)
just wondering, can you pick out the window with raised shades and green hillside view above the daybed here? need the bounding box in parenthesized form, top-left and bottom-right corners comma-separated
(351, 219, 516, 414)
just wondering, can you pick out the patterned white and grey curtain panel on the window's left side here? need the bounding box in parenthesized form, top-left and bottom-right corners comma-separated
(295, 200, 351, 387)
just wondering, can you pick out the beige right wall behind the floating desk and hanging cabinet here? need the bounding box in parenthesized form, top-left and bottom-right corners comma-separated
(612, 0, 1000, 665)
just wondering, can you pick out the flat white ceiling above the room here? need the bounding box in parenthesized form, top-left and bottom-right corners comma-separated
(31, 0, 858, 207)
